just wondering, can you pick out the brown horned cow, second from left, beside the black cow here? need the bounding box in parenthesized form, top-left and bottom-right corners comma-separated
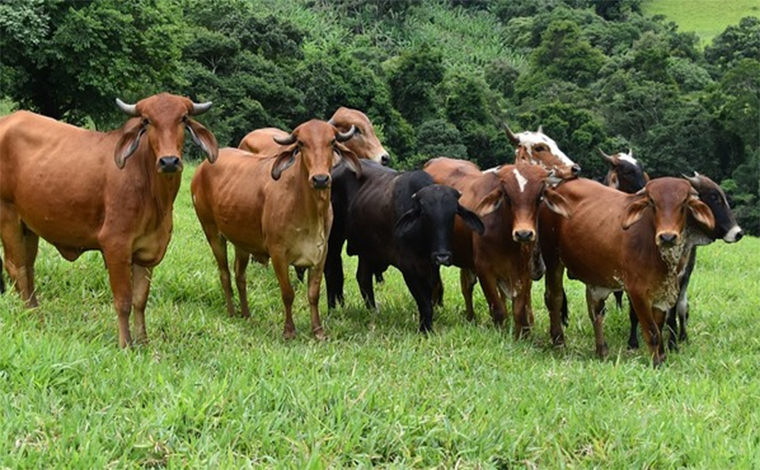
(191, 120, 361, 338)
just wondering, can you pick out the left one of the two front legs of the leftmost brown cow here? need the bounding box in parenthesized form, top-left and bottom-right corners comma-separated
(103, 247, 132, 348)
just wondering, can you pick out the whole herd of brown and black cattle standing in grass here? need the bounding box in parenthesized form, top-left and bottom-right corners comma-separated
(0, 93, 742, 365)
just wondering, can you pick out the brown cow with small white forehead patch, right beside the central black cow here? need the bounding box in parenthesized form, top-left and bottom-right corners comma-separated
(424, 158, 566, 337)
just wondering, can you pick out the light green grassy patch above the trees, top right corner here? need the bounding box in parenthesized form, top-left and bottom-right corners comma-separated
(642, 0, 760, 46)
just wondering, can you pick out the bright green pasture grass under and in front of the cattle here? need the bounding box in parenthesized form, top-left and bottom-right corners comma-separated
(0, 167, 760, 469)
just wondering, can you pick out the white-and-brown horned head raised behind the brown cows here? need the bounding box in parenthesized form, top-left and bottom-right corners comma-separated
(504, 125, 581, 180)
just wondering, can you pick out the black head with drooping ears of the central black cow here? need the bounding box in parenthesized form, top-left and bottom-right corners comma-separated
(394, 184, 485, 266)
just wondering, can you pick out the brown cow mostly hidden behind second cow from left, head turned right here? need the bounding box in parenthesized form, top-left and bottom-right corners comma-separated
(238, 107, 390, 165)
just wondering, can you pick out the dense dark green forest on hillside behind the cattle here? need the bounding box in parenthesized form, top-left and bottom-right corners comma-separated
(0, 0, 760, 235)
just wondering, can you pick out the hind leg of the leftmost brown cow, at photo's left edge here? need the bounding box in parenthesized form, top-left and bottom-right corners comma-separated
(0, 210, 38, 308)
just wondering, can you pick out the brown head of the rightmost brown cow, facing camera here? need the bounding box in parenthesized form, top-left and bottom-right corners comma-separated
(623, 178, 715, 248)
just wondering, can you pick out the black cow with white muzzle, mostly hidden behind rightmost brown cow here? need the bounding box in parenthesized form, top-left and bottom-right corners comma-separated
(628, 172, 744, 349)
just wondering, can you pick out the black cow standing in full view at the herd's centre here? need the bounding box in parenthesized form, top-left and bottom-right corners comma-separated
(325, 161, 484, 332)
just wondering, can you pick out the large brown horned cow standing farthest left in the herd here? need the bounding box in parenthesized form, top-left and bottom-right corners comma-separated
(0, 93, 218, 347)
